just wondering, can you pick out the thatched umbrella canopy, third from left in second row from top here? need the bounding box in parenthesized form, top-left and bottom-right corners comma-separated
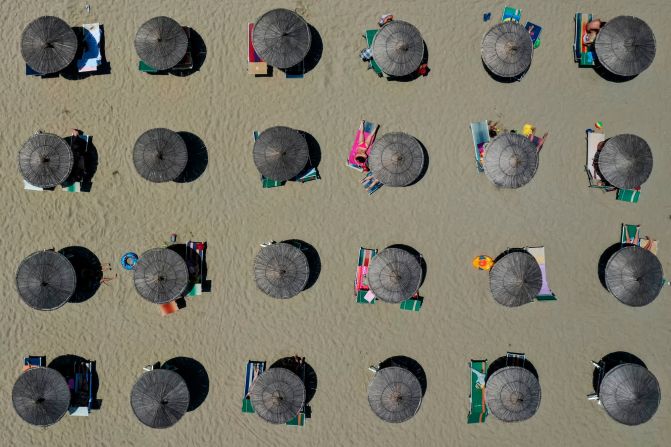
(253, 126, 309, 182)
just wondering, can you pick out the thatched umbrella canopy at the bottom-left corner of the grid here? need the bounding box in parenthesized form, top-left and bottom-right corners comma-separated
(12, 368, 70, 427)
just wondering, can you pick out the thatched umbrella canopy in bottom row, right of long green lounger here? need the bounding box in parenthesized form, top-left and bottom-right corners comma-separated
(485, 366, 541, 422)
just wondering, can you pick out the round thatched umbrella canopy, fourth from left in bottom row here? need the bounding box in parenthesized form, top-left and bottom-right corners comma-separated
(368, 366, 422, 422)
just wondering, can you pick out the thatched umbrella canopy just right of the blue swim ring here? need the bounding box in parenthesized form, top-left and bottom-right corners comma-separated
(133, 248, 189, 304)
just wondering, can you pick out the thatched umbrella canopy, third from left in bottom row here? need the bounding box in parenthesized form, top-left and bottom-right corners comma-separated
(249, 367, 305, 424)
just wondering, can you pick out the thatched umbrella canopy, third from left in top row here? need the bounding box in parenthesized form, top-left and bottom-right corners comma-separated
(252, 8, 312, 68)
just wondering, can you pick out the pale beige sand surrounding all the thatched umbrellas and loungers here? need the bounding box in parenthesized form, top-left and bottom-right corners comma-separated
(0, 0, 671, 447)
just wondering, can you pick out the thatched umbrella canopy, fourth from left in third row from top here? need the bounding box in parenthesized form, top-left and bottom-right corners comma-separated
(368, 247, 422, 303)
